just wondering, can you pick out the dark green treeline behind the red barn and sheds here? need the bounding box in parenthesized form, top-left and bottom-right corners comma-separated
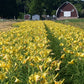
(0, 0, 84, 19)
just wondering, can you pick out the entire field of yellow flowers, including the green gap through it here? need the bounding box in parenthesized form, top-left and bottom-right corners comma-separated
(0, 21, 84, 84)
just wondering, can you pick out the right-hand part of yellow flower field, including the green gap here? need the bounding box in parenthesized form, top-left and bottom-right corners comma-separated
(45, 21, 84, 84)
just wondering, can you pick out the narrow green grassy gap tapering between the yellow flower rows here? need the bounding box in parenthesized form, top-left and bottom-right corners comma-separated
(45, 24, 63, 60)
